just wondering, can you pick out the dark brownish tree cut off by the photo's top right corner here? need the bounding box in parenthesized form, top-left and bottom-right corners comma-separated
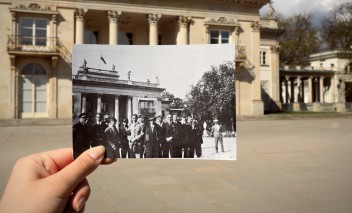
(321, 2, 352, 50)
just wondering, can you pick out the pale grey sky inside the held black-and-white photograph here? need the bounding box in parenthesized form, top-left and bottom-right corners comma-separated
(72, 44, 235, 99)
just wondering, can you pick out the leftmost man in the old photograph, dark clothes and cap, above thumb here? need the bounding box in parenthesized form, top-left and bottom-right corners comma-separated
(72, 113, 91, 159)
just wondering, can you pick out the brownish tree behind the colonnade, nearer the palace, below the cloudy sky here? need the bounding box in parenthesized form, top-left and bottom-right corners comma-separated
(277, 13, 320, 66)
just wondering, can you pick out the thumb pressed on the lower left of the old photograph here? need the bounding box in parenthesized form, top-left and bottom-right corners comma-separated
(52, 146, 105, 196)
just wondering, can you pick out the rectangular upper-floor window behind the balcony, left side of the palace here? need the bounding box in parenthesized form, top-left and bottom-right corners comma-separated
(20, 18, 48, 46)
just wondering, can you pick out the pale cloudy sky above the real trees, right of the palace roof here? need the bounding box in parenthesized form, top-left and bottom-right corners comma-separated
(260, 0, 351, 26)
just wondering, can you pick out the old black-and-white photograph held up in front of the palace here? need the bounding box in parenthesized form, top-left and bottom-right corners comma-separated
(72, 44, 237, 160)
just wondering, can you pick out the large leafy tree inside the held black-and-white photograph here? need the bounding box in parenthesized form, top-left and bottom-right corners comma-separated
(187, 62, 236, 131)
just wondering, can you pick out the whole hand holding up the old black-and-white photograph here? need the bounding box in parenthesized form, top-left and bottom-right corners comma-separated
(0, 146, 113, 212)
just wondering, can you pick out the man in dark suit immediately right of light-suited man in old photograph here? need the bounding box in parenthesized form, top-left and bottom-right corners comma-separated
(144, 117, 159, 158)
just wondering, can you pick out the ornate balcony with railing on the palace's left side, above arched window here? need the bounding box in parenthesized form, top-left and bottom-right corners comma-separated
(7, 35, 72, 65)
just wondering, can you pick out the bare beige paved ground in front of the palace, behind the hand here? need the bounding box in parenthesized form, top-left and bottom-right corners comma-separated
(0, 118, 352, 213)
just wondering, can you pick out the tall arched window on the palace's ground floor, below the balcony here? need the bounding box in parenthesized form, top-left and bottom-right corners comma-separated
(19, 63, 47, 117)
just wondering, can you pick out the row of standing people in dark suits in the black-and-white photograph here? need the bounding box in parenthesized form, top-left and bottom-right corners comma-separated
(73, 113, 208, 158)
